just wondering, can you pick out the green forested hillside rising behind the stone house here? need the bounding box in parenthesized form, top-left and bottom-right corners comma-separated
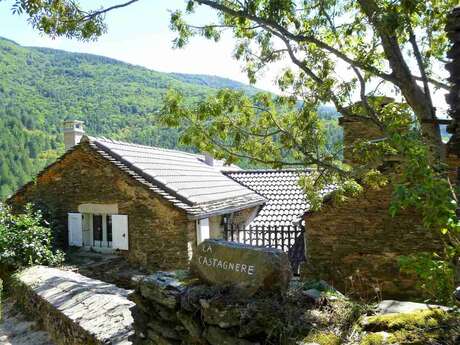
(0, 38, 340, 199)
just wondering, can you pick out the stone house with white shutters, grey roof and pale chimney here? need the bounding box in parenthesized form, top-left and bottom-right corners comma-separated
(7, 121, 266, 269)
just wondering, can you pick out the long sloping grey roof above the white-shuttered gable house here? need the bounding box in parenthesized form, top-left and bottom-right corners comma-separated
(83, 137, 266, 218)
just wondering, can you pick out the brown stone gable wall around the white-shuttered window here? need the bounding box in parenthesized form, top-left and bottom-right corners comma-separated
(9, 143, 196, 270)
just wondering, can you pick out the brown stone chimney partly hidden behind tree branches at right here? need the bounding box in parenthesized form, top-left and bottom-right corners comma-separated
(339, 97, 394, 165)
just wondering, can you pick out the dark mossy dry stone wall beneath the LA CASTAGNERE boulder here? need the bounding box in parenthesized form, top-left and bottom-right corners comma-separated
(130, 271, 310, 345)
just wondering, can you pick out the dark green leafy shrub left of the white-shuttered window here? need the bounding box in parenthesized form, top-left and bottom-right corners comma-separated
(0, 204, 64, 270)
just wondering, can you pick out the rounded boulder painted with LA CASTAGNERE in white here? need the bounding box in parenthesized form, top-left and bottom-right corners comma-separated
(191, 239, 292, 295)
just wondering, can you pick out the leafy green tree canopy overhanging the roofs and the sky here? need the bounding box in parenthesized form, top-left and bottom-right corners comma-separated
(6, 0, 459, 300)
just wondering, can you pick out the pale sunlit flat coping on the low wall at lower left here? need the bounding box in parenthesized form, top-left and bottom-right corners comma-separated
(15, 266, 134, 345)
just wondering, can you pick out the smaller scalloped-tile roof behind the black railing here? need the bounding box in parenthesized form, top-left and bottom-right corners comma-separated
(225, 169, 332, 226)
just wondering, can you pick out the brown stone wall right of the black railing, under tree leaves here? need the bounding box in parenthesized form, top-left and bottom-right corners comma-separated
(301, 186, 442, 298)
